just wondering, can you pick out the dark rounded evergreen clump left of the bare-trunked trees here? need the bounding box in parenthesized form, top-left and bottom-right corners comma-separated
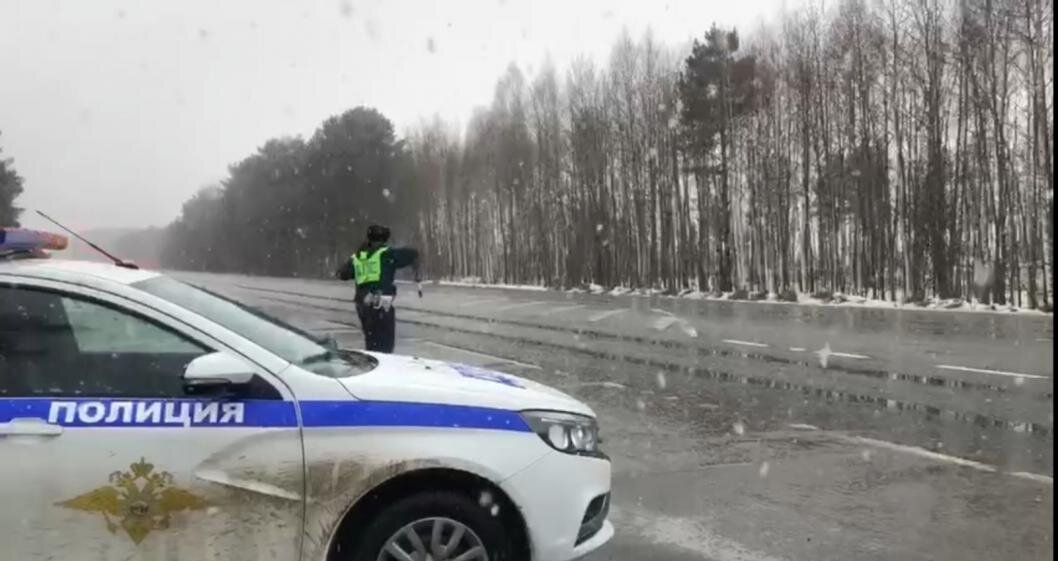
(161, 107, 419, 276)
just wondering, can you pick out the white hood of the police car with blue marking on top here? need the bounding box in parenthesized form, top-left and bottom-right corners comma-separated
(339, 352, 595, 417)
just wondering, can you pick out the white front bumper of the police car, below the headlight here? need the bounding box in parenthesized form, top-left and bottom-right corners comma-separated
(500, 452, 614, 561)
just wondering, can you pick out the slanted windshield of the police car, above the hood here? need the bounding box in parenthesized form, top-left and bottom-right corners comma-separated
(133, 276, 376, 377)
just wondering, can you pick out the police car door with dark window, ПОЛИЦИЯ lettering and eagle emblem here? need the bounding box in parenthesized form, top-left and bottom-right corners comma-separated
(0, 279, 304, 561)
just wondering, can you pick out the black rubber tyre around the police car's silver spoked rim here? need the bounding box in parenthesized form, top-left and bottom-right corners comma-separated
(334, 491, 517, 561)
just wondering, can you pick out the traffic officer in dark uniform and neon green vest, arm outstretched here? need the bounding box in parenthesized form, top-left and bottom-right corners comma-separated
(338, 224, 422, 352)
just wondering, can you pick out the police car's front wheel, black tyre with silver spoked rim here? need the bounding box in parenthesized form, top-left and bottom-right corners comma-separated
(351, 491, 512, 561)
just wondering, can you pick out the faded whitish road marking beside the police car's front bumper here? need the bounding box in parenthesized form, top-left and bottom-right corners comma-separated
(609, 505, 791, 561)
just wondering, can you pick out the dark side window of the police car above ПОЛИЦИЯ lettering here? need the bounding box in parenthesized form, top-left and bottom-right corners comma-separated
(0, 287, 209, 397)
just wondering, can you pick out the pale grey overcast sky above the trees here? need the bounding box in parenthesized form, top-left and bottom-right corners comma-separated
(0, 0, 797, 229)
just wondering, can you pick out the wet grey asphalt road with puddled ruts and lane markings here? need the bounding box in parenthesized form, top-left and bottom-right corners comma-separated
(178, 273, 1054, 561)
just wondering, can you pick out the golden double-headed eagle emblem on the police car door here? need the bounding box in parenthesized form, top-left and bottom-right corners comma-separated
(56, 458, 208, 544)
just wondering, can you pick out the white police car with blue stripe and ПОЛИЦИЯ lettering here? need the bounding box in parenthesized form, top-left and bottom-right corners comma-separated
(0, 230, 614, 561)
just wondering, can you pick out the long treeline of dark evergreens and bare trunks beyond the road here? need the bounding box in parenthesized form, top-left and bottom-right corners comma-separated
(156, 0, 1054, 307)
